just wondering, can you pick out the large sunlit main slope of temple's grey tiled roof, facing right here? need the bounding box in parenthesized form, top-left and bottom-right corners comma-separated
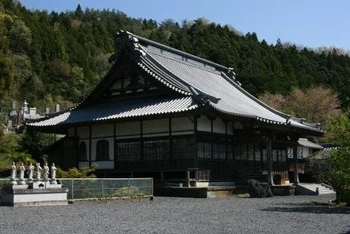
(129, 32, 322, 132)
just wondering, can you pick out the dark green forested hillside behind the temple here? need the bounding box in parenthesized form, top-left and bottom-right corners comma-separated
(0, 0, 350, 112)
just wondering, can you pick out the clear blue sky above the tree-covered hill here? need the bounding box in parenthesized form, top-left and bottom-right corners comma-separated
(20, 0, 350, 51)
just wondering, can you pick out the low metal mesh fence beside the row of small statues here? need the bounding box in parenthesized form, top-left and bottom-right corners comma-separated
(0, 178, 153, 200)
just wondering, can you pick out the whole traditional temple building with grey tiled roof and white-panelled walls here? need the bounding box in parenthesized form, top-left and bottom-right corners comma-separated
(27, 31, 323, 186)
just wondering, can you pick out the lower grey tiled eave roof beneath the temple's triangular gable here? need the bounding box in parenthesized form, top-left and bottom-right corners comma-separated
(28, 97, 198, 127)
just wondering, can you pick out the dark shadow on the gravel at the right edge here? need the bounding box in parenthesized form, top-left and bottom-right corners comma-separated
(262, 203, 350, 215)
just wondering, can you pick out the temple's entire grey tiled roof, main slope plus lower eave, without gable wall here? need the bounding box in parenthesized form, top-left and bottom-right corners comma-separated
(28, 32, 323, 134)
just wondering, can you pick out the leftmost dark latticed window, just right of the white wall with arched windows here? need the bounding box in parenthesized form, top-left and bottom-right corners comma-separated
(116, 141, 141, 162)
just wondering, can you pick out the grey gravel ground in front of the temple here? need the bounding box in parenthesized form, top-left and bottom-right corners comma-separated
(0, 195, 350, 234)
